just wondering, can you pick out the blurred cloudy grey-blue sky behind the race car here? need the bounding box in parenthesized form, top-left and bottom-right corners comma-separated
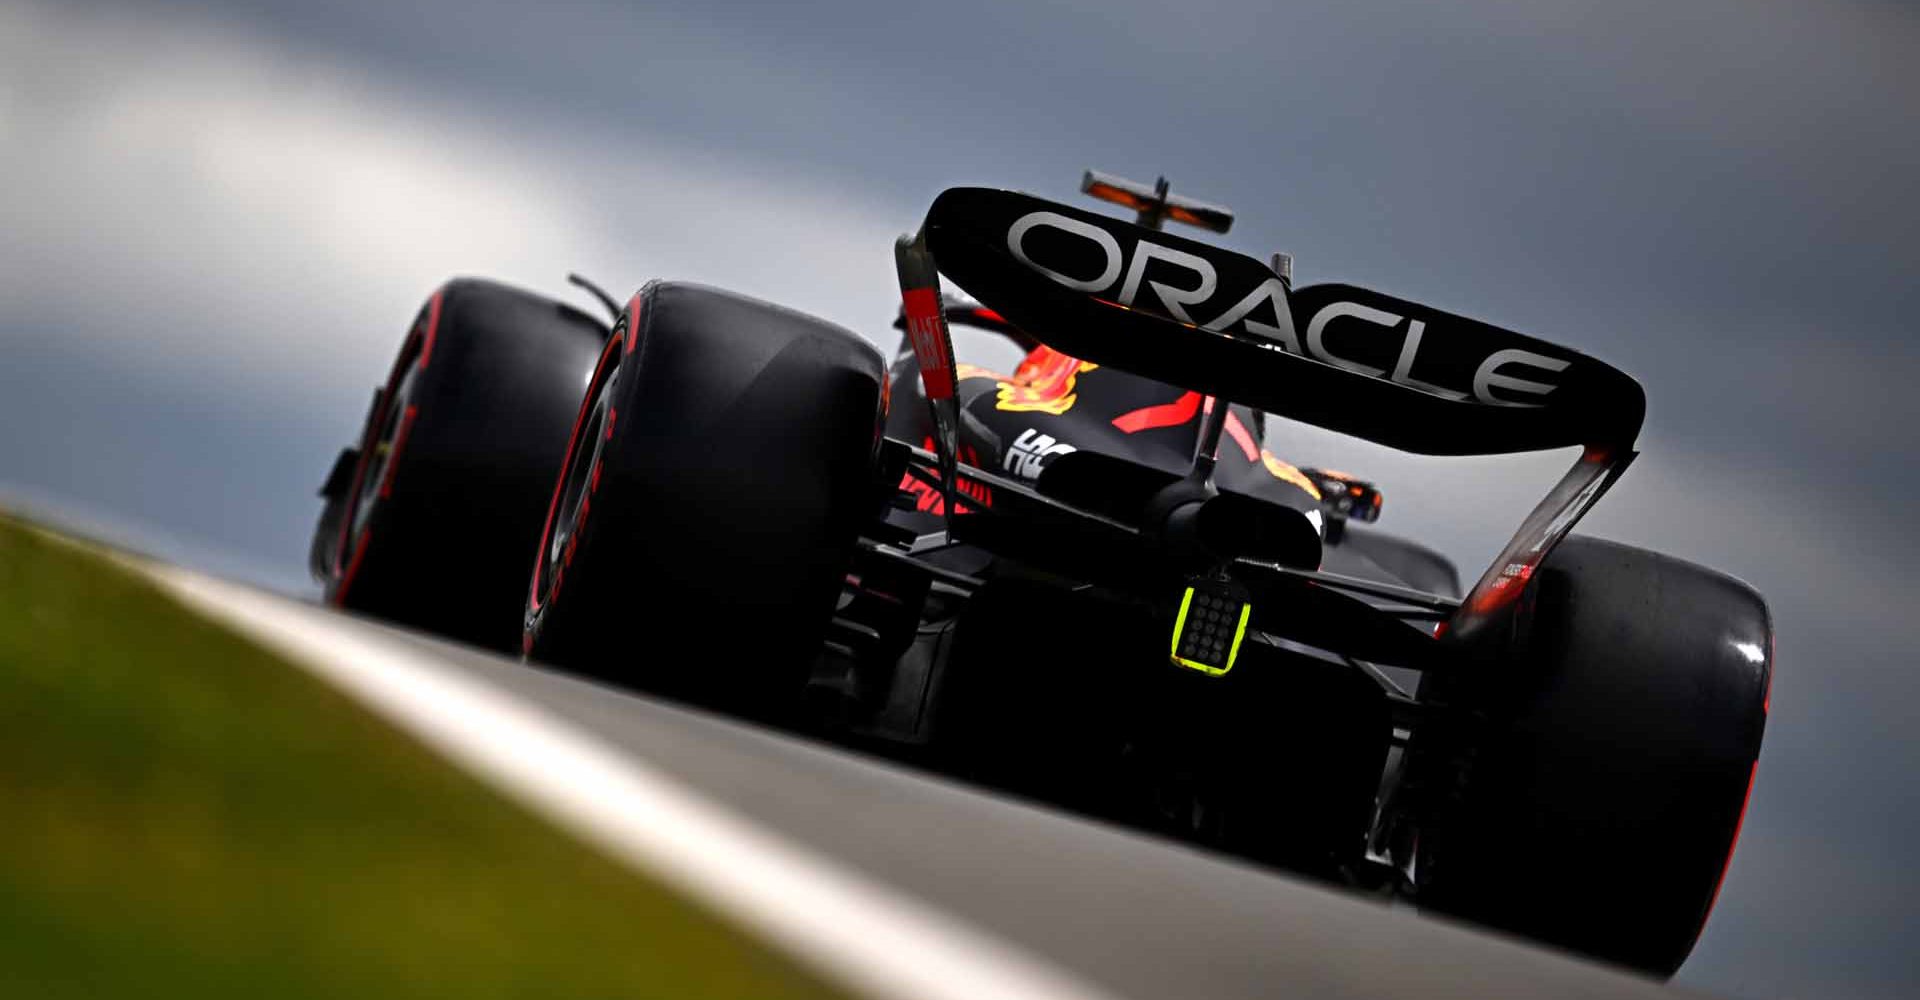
(0, 0, 1920, 998)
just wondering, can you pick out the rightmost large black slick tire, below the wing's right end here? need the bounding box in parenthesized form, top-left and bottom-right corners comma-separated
(1417, 536, 1772, 977)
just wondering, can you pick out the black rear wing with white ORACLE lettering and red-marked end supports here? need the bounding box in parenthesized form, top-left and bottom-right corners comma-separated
(897, 188, 1645, 637)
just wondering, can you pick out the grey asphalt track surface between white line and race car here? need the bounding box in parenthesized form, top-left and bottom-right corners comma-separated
(210, 579, 1704, 1000)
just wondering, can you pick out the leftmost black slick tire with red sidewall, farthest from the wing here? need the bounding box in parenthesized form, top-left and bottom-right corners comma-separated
(321, 278, 607, 651)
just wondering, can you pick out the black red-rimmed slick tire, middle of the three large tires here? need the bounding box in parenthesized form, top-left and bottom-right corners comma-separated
(524, 282, 885, 716)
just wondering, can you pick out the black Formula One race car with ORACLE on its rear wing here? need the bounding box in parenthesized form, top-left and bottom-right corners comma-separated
(313, 175, 1772, 975)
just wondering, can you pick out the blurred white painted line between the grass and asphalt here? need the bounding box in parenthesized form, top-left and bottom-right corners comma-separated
(142, 564, 1112, 1000)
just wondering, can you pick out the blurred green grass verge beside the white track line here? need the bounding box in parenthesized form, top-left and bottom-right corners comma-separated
(0, 518, 835, 1000)
